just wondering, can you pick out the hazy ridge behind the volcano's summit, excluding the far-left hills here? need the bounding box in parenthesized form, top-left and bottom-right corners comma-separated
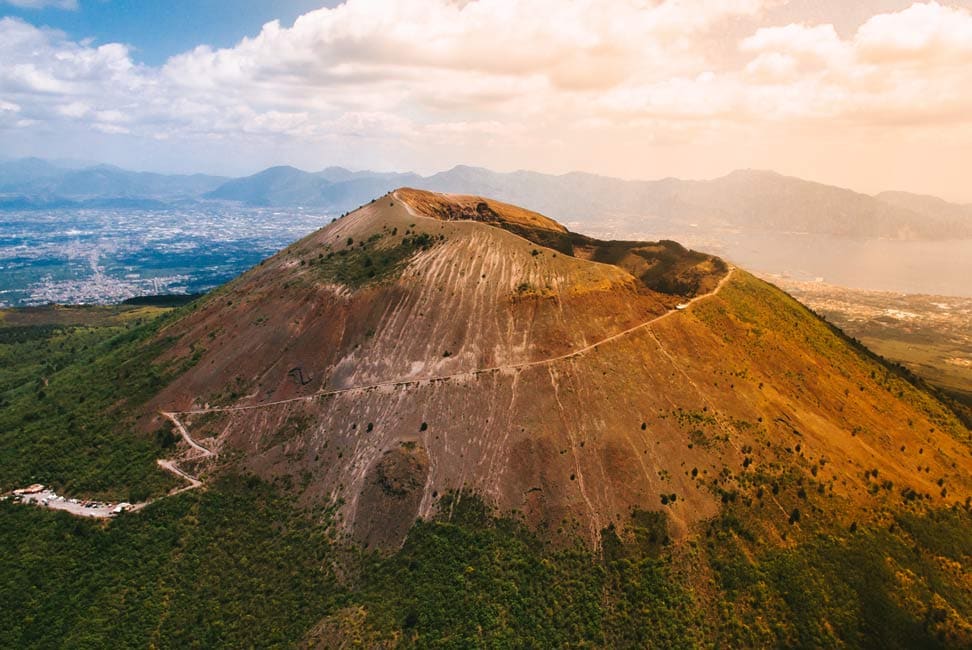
(208, 165, 972, 239)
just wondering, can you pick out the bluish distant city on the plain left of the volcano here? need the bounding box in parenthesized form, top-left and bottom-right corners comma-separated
(0, 205, 330, 307)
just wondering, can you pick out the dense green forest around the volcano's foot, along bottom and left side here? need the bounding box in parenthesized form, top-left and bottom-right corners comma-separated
(0, 307, 972, 648)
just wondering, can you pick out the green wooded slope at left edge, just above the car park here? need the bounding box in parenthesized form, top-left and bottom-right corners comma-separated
(0, 308, 193, 501)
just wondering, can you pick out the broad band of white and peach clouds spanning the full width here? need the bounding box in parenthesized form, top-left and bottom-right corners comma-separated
(0, 0, 972, 190)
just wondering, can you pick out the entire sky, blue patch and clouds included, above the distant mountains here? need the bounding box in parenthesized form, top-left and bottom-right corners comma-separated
(0, 0, 972, 202)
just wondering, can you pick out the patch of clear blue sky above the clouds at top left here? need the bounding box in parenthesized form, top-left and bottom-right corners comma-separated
(0, 0, 339, 65)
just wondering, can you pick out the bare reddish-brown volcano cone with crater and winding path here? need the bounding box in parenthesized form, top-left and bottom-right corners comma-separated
(139, 190, 972, 546)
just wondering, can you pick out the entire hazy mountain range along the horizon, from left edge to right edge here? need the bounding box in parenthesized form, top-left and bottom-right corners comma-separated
(0, 158, 972, 240)
